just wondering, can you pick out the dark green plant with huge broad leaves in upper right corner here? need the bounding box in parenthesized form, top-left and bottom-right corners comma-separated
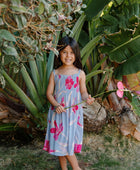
(97, 0, 140, 114)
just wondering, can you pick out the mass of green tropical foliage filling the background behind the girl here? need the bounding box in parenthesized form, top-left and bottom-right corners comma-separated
(0, 0, 140, 130)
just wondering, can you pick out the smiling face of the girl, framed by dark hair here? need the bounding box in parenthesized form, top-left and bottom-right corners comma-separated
(60, 45, 75, 66)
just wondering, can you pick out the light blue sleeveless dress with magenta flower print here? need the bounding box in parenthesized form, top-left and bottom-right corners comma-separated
(43, 70, 83, 156)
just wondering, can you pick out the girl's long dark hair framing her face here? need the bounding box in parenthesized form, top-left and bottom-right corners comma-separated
(54, 36, 82, 69)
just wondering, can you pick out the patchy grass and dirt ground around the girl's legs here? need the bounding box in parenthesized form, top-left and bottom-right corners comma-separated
(0, 124, 140, 170)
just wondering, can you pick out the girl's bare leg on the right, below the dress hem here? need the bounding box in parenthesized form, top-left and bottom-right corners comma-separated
(66, 154, 81, 170)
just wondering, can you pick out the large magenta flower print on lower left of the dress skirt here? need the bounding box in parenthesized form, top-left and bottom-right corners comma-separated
(50, 120, 63, 140)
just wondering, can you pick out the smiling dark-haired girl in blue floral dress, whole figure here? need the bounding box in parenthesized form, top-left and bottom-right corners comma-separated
(43, 37, 94, 170)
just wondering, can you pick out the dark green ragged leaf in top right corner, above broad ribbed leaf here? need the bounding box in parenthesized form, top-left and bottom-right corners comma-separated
(98, 0, 140, 33)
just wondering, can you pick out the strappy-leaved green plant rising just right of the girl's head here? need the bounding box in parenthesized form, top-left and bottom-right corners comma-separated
(73, 0, 113, 96)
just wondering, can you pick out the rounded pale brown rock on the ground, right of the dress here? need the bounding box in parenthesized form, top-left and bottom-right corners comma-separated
(83, 101, 107, 132)
